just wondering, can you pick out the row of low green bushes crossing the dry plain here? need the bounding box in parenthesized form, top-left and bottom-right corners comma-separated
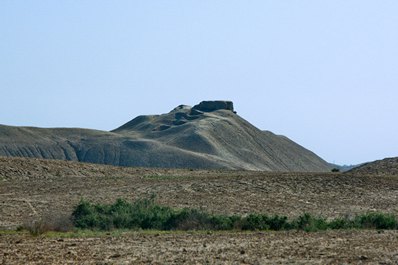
(72, 198, 398, 231)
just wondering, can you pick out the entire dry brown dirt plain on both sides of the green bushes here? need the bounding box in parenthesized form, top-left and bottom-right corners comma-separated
(0, 157, 398, 264)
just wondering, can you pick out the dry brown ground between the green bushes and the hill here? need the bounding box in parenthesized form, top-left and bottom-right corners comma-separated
(0, 158, 398, 229)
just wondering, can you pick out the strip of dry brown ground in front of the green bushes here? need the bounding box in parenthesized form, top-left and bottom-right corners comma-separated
(0, 231, 398, 264)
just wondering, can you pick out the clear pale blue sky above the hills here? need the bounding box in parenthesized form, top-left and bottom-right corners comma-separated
(0, 0, 398, 164)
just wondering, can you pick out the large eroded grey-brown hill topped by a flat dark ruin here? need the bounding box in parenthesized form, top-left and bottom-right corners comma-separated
(0, 101, 331, 172)
